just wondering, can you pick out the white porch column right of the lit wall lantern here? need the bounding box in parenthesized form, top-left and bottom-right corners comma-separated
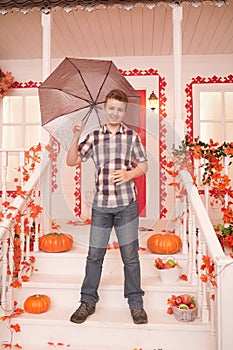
(172, 5, 184, 147)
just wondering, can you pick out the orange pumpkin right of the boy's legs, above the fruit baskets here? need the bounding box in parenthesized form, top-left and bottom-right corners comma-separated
(147, 233, 182, 254)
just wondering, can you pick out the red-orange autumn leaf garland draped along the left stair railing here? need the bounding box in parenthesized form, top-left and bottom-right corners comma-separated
(0, 144, 42, 349)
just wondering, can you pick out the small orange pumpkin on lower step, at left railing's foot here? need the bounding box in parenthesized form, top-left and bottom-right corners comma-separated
(24, 294, 50, 314)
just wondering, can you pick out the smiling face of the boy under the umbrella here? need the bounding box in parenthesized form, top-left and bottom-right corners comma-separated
(105, 99, 126, 125)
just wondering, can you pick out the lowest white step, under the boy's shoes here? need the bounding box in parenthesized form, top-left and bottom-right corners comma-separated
(0, 306, 210, 350)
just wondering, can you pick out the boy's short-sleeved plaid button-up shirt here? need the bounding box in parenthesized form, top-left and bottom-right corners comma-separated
(78, 124, 147, 208)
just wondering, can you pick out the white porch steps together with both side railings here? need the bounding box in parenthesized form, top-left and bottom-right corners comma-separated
(0, 145, 233, 350)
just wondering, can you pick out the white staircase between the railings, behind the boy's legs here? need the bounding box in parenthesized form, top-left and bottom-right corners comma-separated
(0, 226, 213, 350)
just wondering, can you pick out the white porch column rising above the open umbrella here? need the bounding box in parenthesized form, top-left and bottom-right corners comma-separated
(41, 12, 51, 81)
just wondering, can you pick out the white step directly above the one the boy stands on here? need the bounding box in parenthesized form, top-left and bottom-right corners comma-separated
(15, 272, 196, 309)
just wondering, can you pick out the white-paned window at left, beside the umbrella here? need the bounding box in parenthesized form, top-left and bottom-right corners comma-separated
(0, 88, 45, 183)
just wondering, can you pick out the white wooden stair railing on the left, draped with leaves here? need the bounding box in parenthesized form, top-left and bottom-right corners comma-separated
(0, 150, 50, 314)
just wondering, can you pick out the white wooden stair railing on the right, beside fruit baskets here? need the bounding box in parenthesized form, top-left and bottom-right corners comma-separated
(180, 170, 233, 350)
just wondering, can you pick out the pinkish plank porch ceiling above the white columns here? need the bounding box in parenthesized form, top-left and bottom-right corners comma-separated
(0, 0, 233, 60)
